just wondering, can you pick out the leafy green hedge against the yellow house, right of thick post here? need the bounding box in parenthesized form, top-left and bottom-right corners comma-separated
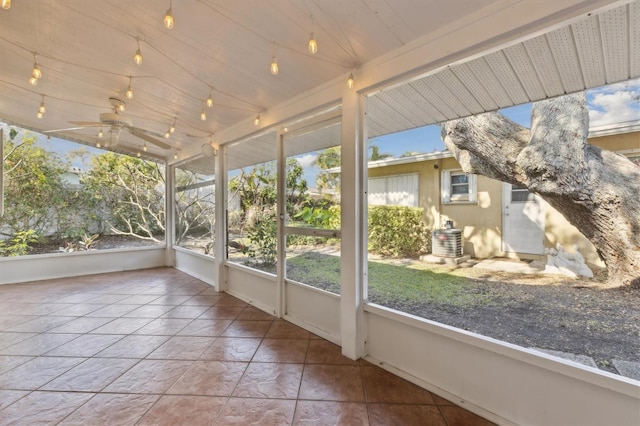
(369, 206, 430, 257)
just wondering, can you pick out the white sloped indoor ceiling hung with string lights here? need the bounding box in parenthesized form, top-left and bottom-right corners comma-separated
(0, 0, 496, 157)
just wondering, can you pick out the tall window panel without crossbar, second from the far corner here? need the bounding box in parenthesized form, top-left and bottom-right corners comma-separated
(227, 132, 278, 273)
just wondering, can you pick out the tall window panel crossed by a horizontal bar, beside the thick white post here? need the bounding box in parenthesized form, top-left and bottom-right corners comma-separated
(284, 122, 341, 294)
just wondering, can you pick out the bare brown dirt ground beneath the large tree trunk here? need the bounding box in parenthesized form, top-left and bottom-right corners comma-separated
(382, 268, 640, 373)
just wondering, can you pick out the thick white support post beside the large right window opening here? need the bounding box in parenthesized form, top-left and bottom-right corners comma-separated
(340, 83, 366, 359)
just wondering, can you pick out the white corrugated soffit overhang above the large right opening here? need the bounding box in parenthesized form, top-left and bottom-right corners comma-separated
(367, 2, 640, 137)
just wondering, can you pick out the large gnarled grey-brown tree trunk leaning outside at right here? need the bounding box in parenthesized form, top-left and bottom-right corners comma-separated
(442, 93, 640, 288)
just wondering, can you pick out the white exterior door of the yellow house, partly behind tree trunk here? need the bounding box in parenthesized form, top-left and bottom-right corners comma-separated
(502, 183, 544, 254)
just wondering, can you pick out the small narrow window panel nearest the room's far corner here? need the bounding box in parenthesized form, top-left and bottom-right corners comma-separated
(175, 158, 216, 256)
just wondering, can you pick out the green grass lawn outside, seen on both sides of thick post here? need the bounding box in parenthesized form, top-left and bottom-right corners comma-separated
(287, 252, 490, 306)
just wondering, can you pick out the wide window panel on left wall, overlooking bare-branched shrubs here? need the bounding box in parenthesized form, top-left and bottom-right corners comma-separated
(0, 126, 165, 256)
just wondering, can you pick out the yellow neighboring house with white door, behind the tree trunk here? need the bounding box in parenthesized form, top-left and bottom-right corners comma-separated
(368, 122, 640, 266)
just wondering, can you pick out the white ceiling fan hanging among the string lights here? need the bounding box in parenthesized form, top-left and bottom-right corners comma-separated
(43, 98, 171, 149)
